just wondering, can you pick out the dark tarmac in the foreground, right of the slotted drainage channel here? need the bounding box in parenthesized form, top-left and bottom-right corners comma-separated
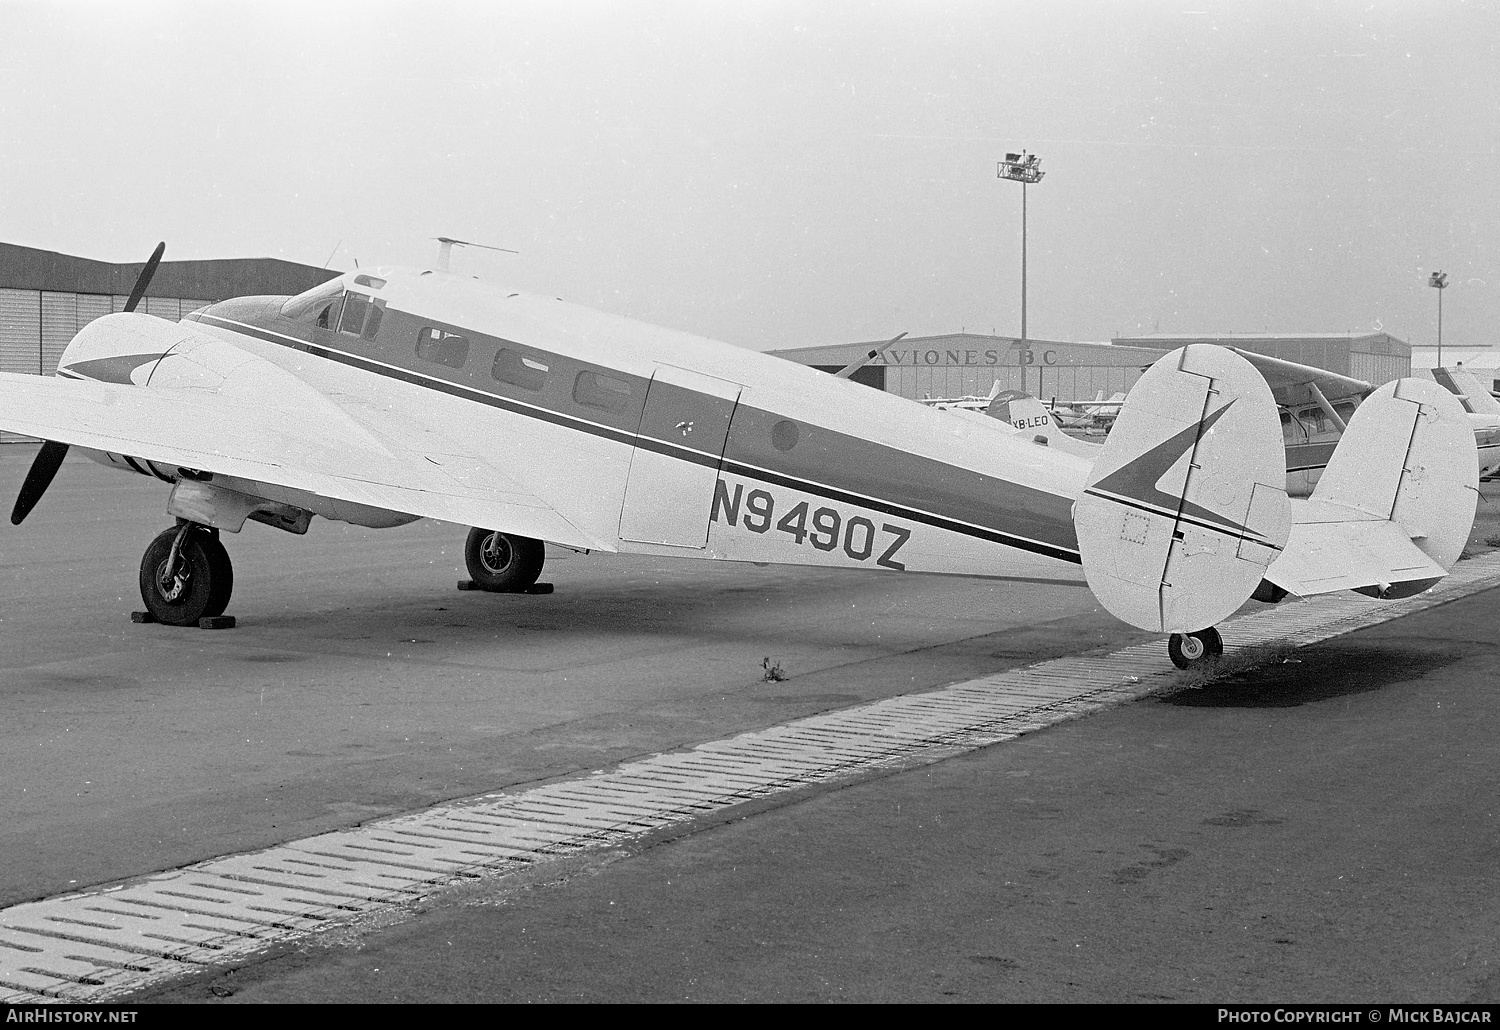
(140, 591, 1500, 1003)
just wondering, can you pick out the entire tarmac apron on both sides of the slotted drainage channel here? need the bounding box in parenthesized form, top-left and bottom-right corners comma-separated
(0, 447, 1500, 1002)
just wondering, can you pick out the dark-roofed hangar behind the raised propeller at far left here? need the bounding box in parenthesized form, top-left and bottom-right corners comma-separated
(0, 243, 339, 442)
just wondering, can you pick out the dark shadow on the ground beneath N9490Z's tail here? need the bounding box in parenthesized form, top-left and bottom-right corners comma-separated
(1157, 640, 1469, 708)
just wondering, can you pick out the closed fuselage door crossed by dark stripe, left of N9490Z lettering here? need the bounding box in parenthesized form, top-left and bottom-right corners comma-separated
(620, 364, 740, 547)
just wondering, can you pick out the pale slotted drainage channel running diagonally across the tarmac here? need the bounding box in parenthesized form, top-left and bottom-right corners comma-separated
(0, 552, 1500, 1005)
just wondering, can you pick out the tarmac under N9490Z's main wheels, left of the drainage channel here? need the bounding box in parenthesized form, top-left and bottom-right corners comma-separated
(0, 445, 1145, 906)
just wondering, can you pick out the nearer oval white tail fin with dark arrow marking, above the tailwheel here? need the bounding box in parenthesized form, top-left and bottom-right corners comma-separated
(1073, 350, 1290, 633)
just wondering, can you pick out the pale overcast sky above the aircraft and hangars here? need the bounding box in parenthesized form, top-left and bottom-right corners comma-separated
(0, 0, 1500, 349)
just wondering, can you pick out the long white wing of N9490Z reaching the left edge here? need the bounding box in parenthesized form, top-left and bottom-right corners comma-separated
(0, 373, 597, 549)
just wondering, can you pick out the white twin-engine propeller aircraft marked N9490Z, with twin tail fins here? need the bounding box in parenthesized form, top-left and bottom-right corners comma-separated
(0, 245, 1478, 667)
